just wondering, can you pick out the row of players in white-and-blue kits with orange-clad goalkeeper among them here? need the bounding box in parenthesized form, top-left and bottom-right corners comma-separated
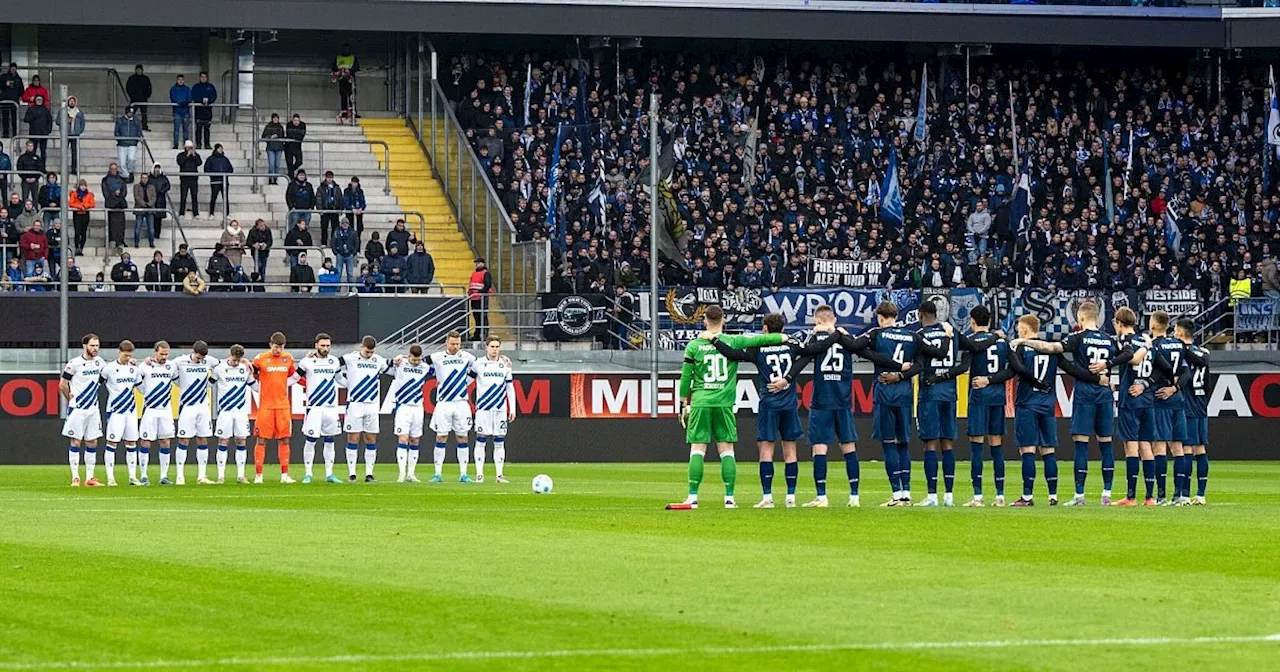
(60, 332, 516, 486)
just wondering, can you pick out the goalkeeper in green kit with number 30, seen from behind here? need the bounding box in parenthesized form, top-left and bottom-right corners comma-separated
(667, 306, 783, 511)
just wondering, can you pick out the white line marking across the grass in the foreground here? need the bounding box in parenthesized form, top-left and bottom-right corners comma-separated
(0, 634, 1280, 669)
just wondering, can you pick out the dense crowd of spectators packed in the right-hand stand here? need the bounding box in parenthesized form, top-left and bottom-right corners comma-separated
(448, 50, 1280, 301)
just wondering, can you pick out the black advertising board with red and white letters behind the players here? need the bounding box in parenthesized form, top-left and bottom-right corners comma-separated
(0, 372, 1280, 465)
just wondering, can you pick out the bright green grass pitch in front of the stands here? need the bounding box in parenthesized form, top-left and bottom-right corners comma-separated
(0, 456, 1280, 672)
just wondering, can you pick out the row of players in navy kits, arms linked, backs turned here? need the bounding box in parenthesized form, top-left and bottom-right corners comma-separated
(713, 302, 1208, 508)
